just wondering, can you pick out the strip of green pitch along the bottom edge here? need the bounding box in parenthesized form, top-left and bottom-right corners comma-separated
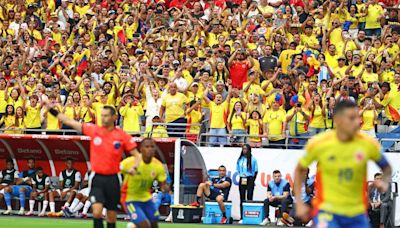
(0, 216, 245, 228)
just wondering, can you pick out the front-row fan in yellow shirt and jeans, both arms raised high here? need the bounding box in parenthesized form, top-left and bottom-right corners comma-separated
(203, 80, 232, 146)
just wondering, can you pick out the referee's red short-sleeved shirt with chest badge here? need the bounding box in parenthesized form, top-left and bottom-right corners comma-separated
(82, 124, 137, 175)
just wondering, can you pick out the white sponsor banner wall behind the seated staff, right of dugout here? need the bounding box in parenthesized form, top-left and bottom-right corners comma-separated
(199, 147, 400, 225)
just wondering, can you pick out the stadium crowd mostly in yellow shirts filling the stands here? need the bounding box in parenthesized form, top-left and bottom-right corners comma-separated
(0, 0, 400, 146)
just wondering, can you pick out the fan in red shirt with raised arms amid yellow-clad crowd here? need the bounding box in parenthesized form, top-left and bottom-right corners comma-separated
(228, 48, 254, 89)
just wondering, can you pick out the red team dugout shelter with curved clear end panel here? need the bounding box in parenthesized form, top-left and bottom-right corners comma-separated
(0, 134, 207, 207)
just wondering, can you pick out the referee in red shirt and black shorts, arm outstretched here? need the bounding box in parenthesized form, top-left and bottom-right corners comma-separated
(45, 102, 141, 228)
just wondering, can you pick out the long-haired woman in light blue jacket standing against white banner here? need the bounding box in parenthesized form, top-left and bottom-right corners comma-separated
(236, 144, 258, 223)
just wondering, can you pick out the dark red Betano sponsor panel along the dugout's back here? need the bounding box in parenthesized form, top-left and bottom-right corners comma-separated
(0, 134, 176, 176)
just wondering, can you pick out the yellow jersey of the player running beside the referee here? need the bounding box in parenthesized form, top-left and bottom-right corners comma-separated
(121, 156, 167, 202)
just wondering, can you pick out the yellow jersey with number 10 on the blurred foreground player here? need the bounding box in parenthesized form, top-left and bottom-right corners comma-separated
(300, 130, 382, 217)
